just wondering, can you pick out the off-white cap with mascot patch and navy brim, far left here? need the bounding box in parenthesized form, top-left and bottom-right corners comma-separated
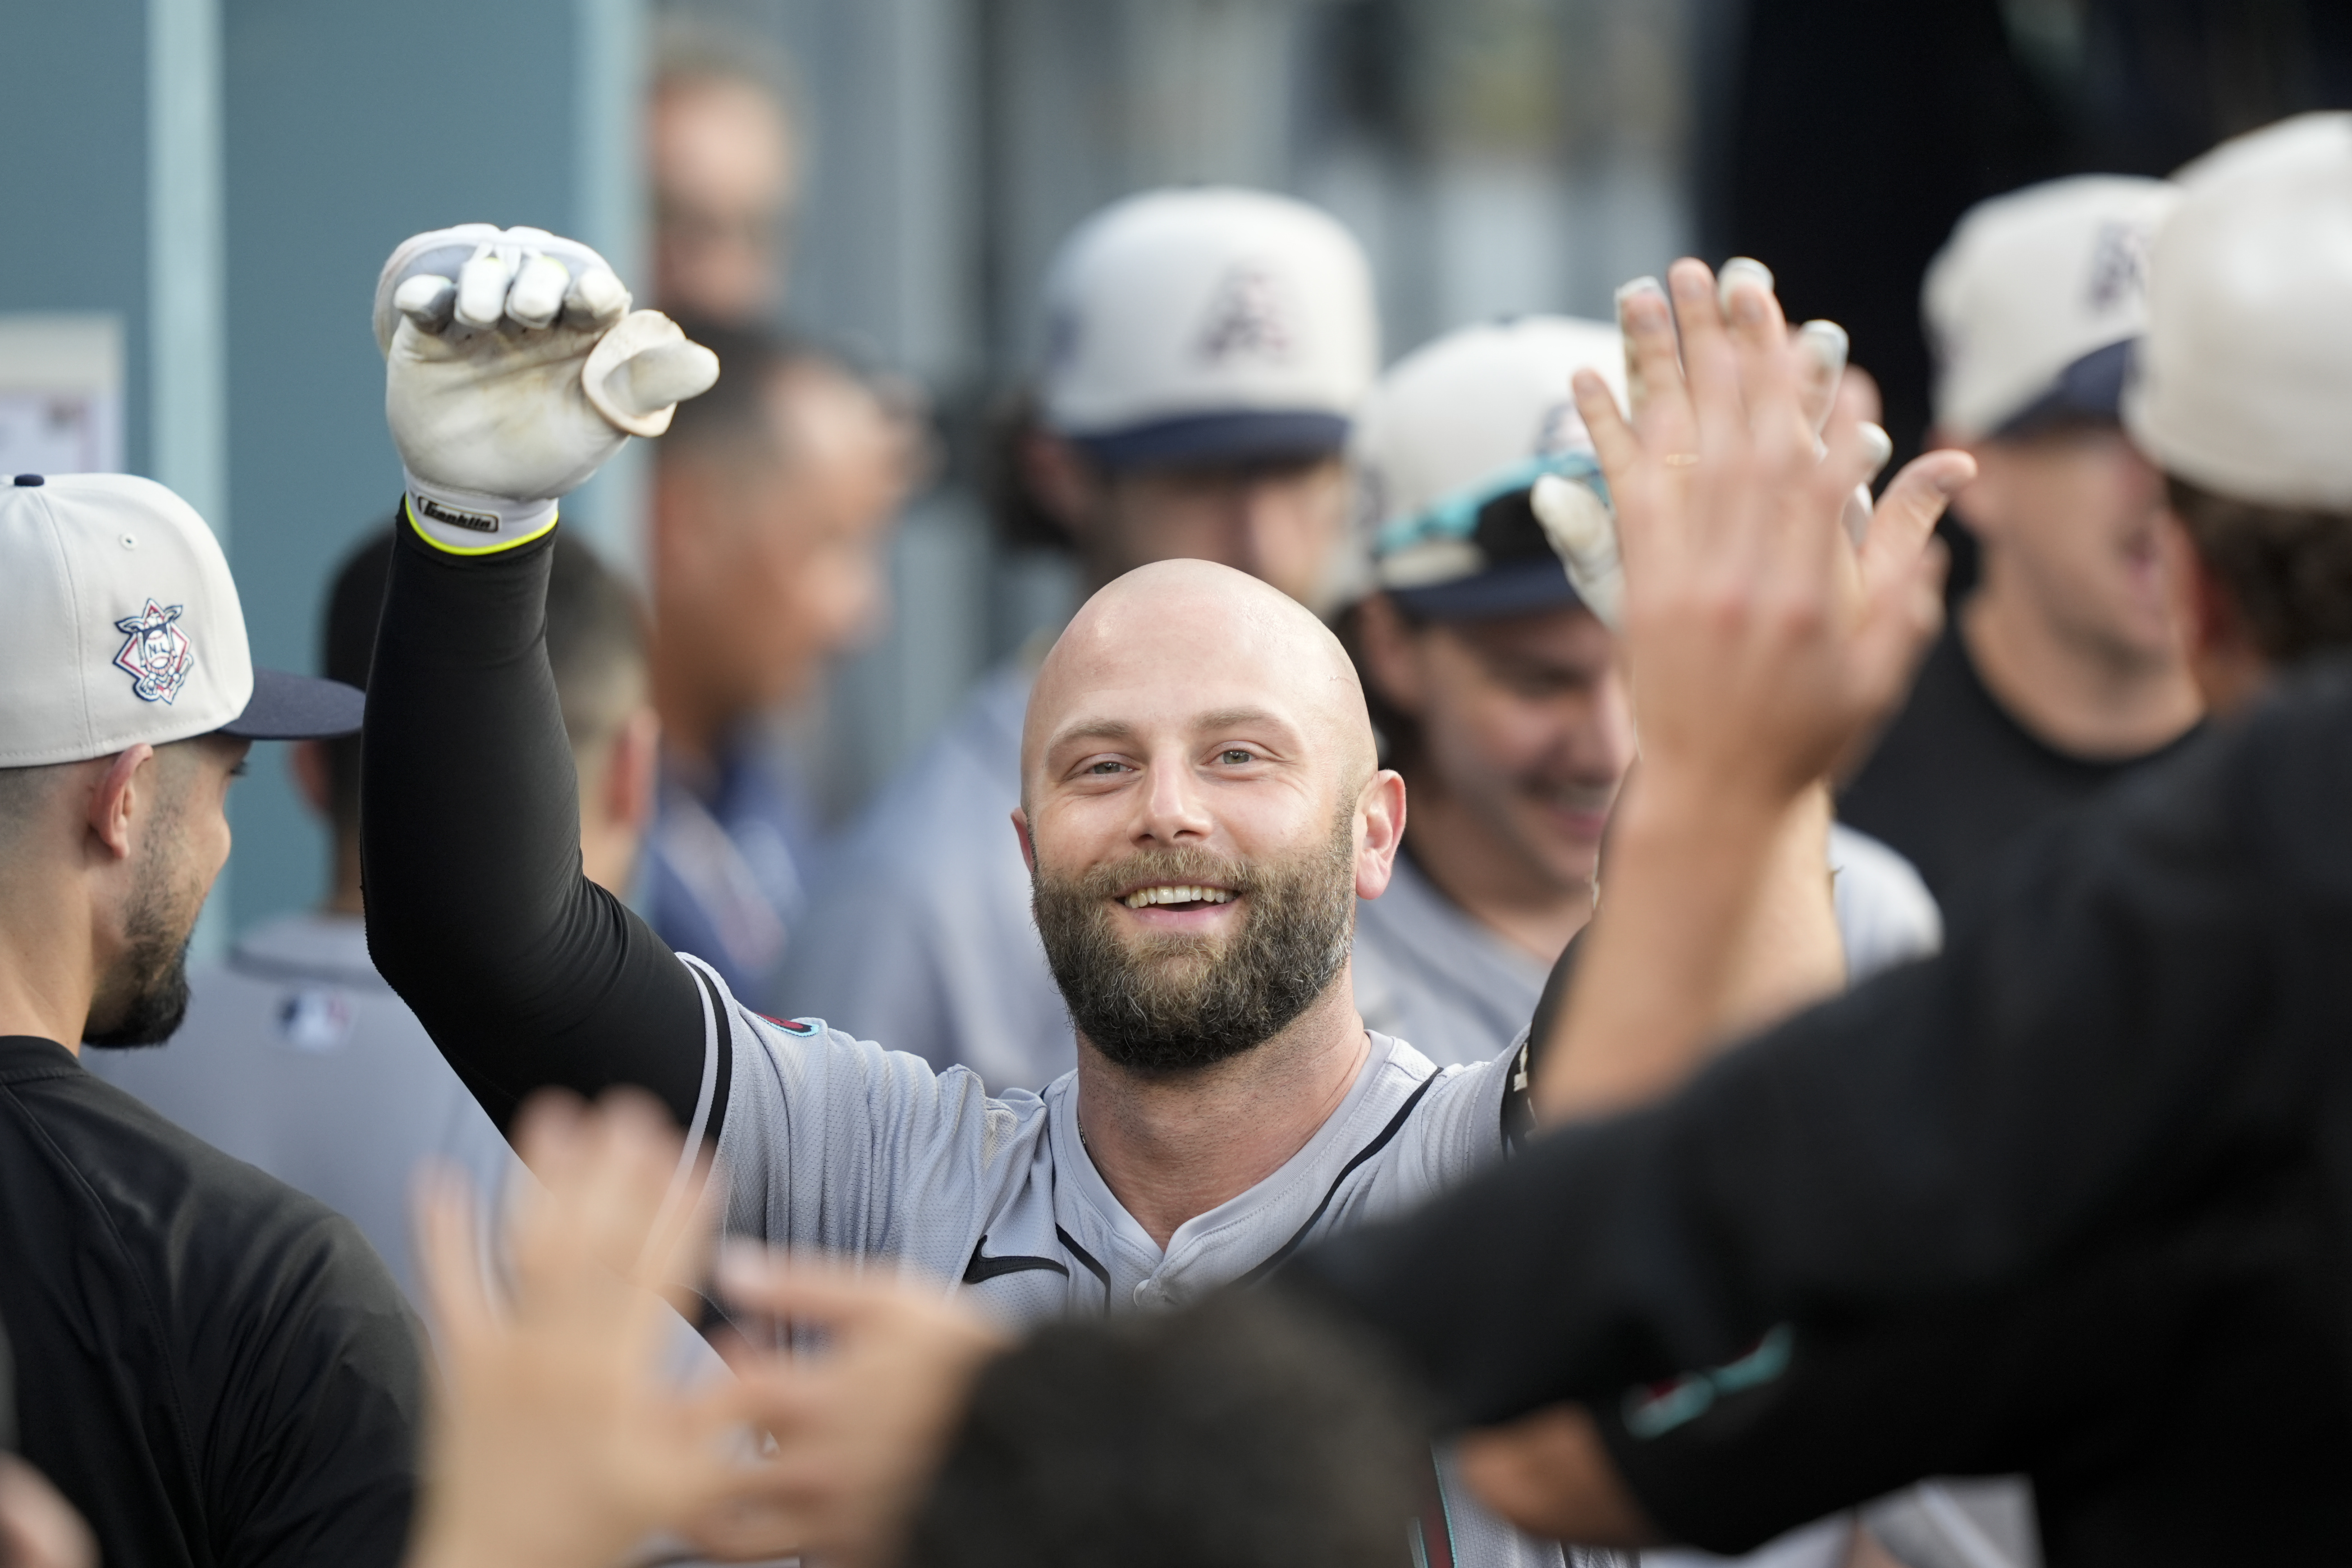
(0, 472, 365, 769)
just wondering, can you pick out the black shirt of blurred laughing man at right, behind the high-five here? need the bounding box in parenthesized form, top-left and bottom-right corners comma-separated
(1837, 616, 2199, 919)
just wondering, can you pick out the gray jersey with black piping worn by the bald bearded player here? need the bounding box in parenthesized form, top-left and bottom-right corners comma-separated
(687, 959, 1606, 1568)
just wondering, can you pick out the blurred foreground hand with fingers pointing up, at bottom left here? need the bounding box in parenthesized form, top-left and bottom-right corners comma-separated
(409, 1091, 753, 1568)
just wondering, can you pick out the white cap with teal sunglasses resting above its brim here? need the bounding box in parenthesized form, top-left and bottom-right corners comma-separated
(1350, 315, 1625, 621)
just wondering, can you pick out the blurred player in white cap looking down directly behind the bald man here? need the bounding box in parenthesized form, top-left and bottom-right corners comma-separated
(778, 188, 1378, 1091)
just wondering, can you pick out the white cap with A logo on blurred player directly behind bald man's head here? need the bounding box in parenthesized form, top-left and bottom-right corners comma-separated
(1039, 188, 1381, 468)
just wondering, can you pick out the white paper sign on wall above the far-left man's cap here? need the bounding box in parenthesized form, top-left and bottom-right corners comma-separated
(0, 313, 122, 475)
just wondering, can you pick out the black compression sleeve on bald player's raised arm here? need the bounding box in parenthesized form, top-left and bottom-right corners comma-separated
(360, 512, 727, 1135)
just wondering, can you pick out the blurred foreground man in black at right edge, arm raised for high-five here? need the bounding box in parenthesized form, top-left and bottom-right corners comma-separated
(1305, 115, 2352, 1568)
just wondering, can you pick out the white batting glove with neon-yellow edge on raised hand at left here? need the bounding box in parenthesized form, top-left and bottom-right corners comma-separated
(376, 224, 720, 555)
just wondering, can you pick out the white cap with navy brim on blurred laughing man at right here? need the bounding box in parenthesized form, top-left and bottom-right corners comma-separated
(1919, 174, 2180, 442)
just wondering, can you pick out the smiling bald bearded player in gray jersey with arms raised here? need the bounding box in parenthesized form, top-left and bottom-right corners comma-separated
(362, 230, 1928, 1563)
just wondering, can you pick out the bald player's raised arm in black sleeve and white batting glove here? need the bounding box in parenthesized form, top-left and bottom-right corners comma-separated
(360, 226, 724, 1133)
